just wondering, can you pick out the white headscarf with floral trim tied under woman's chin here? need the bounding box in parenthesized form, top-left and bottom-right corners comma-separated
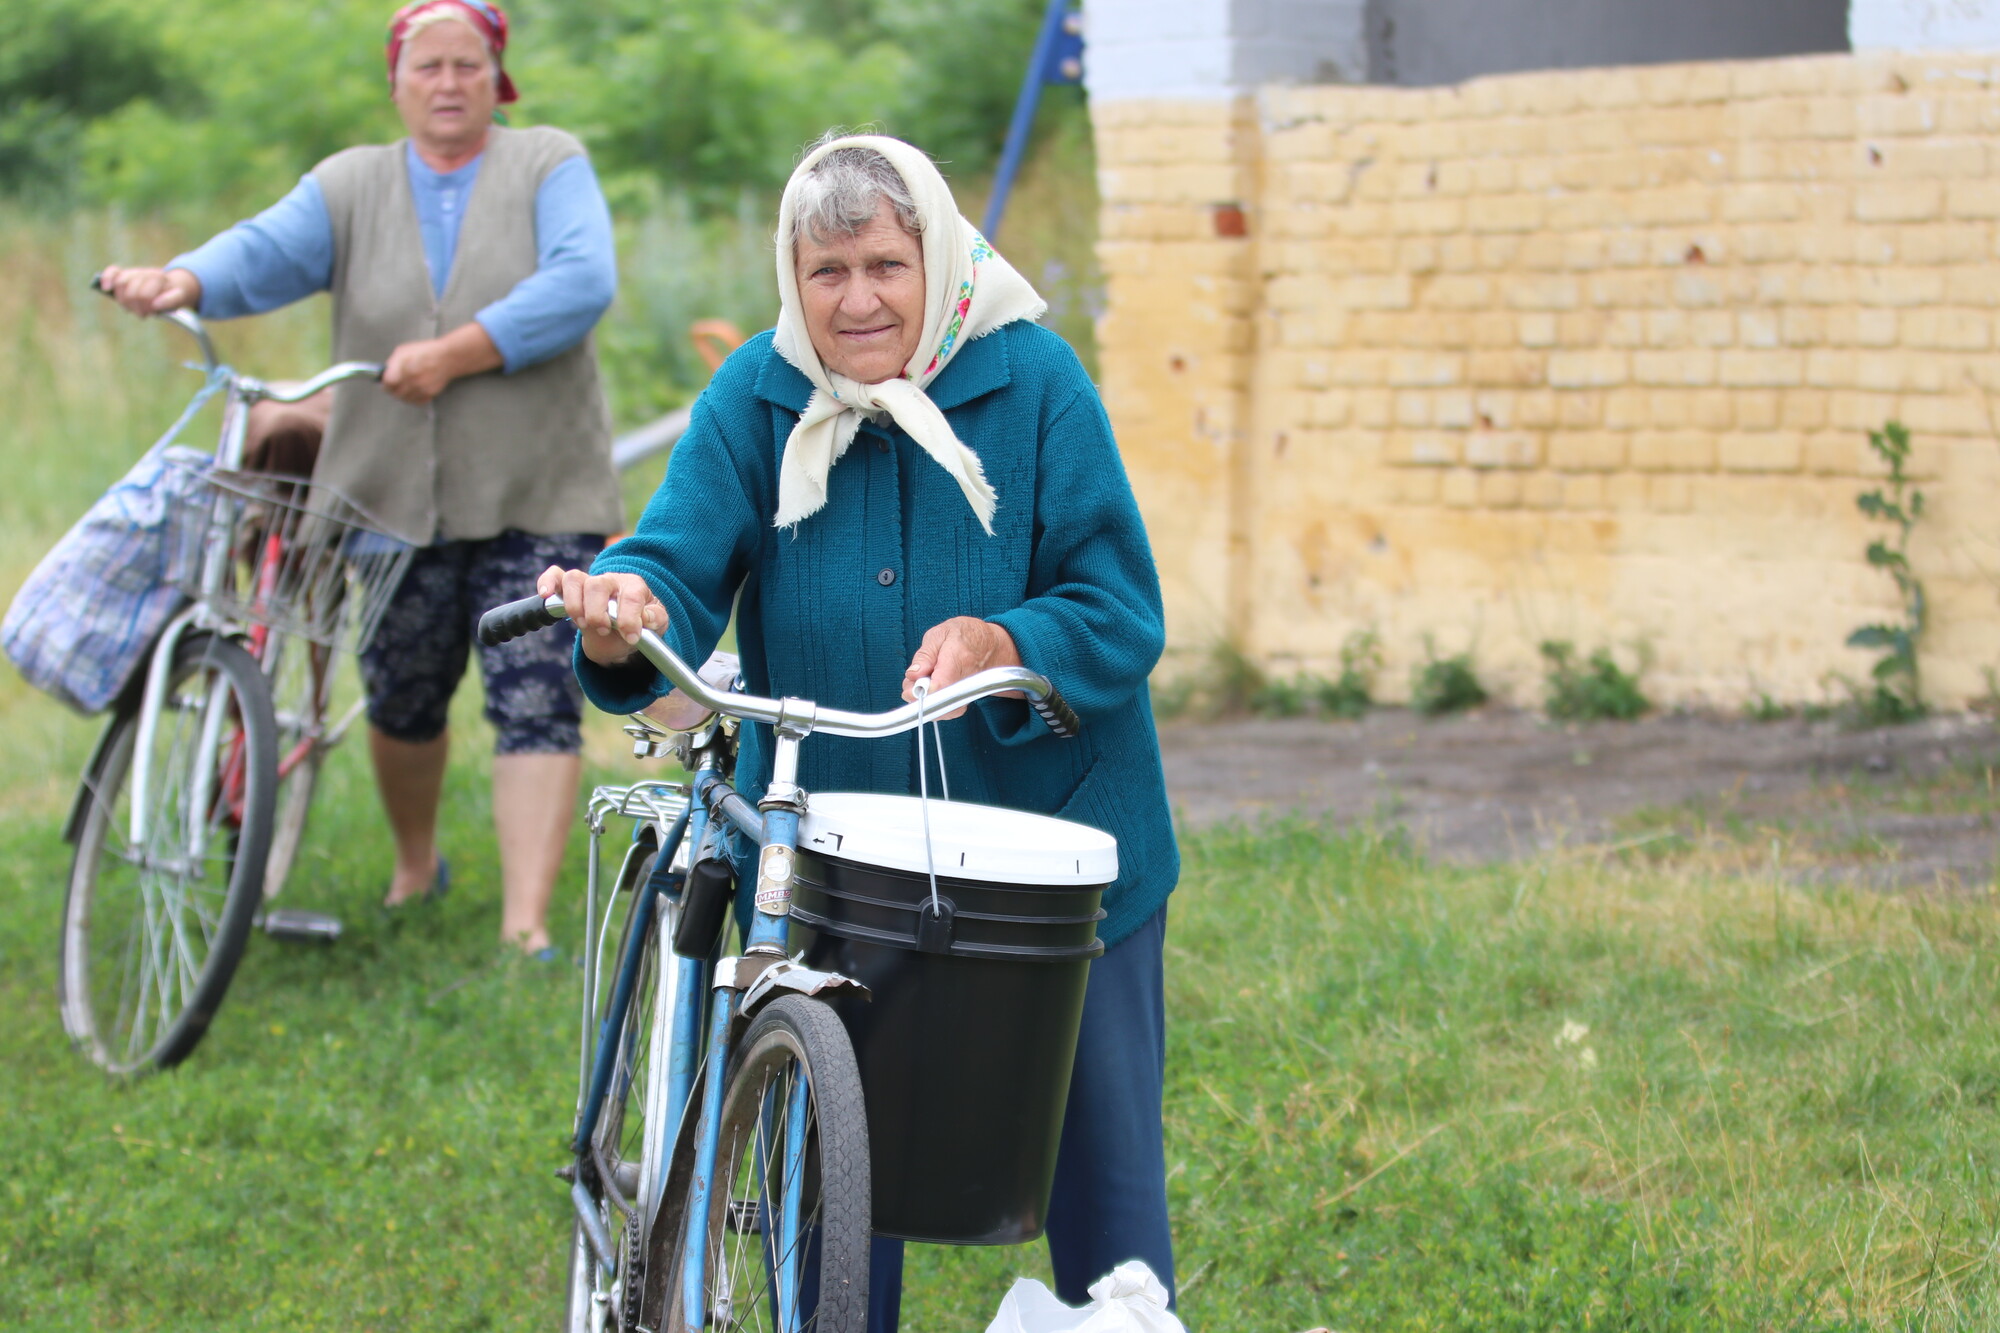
(776, 134, 1048, 536)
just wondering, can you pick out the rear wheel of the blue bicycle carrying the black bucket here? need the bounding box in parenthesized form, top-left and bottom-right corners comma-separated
(568, 857, 680, 1333)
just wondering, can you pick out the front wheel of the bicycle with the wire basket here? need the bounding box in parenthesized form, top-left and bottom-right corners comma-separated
(60, 632, 278, 1075)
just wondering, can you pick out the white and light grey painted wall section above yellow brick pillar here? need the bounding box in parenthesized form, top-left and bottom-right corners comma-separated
(1084, 0, 1368, 102)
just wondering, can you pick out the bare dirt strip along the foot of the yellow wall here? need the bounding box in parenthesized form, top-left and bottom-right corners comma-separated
(1160, 709, 2000, 889)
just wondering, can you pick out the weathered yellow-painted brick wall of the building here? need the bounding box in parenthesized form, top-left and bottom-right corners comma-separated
(1094, 56, 2000, 707)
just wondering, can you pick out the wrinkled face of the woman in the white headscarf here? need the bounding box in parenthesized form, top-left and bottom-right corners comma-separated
(792, 200, 924, 384)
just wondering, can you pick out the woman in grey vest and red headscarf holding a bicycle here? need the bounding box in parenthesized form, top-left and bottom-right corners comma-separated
(102, 0, 624, 957)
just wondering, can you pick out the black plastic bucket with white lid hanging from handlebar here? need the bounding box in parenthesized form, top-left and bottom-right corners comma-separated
(792, 793, 1118, 1245)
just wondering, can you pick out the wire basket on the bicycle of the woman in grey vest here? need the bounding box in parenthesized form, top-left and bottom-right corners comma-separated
(168, 468, 416, 652)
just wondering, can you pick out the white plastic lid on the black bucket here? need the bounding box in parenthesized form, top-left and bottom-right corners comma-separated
(798, 791, 1118, 885)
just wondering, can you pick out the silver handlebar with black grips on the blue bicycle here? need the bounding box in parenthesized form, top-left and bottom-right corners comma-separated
(480, 594, 1082, 737)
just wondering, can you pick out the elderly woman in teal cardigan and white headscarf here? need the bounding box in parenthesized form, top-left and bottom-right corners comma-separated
(540, 136, 1180, 1329)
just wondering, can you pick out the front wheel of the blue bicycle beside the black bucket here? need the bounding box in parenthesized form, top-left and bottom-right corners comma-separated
(644, 995, 870, 1333)
